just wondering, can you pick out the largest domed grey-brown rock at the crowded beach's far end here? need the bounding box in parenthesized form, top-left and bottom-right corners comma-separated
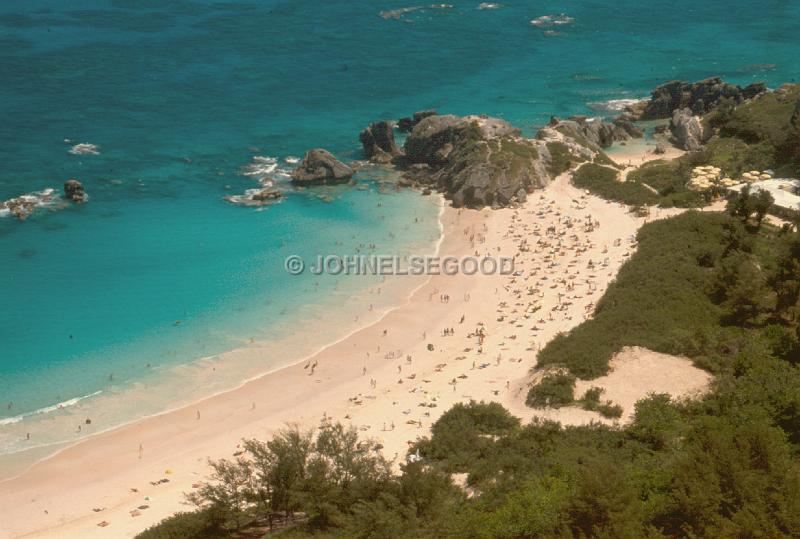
(404, 115, 549, 208)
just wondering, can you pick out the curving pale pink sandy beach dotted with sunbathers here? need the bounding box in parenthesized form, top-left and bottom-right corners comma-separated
(0, 166, 706, 538)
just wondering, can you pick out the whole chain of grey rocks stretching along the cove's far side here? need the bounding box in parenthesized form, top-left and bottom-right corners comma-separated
(284, 77, 800, 208)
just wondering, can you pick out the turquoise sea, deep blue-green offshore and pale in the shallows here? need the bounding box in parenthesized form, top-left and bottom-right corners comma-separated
(0, 0, 800, 464)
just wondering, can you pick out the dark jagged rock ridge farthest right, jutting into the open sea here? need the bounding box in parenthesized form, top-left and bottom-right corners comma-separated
(640, 77, 767, 120)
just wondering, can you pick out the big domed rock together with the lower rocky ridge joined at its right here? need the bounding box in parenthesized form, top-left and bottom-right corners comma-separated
(394, 109, 642, 208)
